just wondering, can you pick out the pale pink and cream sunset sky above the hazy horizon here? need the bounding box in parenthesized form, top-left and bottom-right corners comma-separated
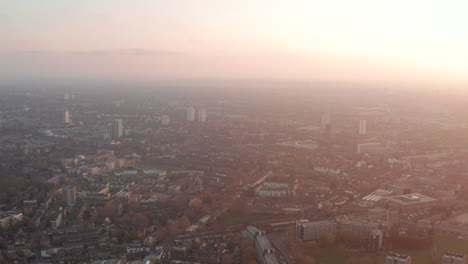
(0, 0, 468, 87)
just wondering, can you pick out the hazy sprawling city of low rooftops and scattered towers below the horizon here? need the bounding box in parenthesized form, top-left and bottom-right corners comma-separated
(0, 85, 468, 264)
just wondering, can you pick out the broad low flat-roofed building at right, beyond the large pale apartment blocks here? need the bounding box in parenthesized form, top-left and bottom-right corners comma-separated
(387, 193, 439, 213)
